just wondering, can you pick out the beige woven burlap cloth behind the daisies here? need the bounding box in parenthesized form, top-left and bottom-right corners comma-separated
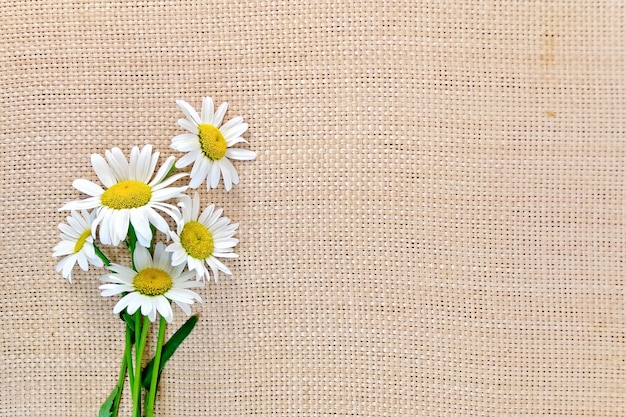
(0, 0, 626, 417)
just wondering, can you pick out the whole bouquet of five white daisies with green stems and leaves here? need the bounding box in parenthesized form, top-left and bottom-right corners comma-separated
(53, 97, 256, 417)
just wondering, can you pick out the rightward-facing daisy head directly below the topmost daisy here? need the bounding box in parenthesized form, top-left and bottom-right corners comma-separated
(165, 193, 239, 281)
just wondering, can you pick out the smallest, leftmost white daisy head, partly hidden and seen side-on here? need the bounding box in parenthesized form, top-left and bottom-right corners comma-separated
(52, 210, 104, 282)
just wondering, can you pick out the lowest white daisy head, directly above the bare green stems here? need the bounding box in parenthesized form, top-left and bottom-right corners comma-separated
(100, 242, 203, 323)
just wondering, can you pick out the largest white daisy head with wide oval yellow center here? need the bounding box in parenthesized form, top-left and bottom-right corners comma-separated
(61, 145, 187, 247)
